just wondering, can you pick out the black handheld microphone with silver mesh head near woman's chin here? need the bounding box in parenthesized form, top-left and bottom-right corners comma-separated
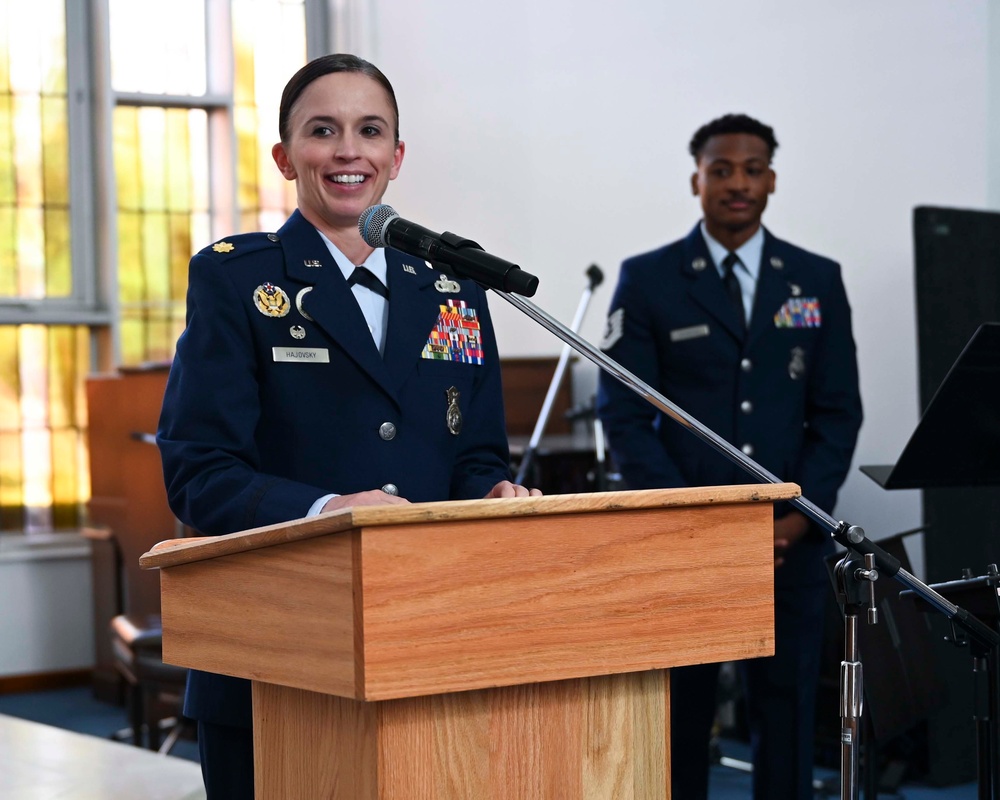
(358, 204, 538, 297)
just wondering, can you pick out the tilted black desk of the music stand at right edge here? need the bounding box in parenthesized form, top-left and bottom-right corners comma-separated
(861, 322, 1000, 489)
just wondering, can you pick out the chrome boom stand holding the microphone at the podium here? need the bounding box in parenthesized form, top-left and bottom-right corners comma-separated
(491, 287, 1000, 800)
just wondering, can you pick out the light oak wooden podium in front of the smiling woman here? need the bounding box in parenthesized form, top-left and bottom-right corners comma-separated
(141, 484, 799, 800)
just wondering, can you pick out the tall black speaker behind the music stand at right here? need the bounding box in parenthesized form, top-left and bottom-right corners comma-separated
(913, 207, 1000, 785)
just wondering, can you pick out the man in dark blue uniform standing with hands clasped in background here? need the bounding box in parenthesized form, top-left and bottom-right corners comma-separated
(598, 115, 862, 800)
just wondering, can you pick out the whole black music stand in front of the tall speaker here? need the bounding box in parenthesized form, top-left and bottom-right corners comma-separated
(861, 322, 1000, 800)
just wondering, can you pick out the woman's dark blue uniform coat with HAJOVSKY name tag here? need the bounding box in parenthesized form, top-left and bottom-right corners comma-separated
(157, 212, 510, 726)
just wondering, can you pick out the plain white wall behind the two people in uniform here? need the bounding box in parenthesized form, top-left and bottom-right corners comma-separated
(355, 0, 988, 568)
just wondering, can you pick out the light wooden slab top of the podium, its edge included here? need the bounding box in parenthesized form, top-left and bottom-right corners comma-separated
(139, 483, 801, 569)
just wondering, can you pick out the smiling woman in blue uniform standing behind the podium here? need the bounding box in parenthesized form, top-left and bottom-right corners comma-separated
(157, 55, 538, 800)
